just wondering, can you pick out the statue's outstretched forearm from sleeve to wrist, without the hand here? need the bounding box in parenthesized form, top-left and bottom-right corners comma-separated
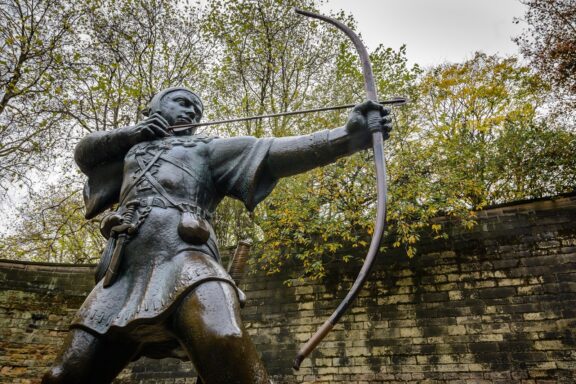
(267, 127, 371, 178)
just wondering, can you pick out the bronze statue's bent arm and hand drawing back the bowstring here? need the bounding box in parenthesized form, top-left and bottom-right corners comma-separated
(74, 113, 169, 173)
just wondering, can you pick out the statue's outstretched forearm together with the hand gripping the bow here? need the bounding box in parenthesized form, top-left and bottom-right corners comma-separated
(267, 101, 392, 178)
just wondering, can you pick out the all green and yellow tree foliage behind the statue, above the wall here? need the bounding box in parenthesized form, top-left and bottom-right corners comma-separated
(0, 0, 576, 278)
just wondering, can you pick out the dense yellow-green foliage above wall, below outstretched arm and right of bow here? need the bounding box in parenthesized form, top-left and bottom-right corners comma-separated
(252, 48, 576, 278)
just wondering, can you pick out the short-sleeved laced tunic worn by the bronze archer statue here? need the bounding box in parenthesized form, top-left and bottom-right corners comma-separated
(72, 135, 277, 358)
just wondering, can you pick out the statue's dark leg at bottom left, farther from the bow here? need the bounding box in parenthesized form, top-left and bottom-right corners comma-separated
(42, 329, 137, 384)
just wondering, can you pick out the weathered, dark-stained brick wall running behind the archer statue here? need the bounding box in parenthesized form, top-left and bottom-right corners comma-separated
(0, 196, 576, 384)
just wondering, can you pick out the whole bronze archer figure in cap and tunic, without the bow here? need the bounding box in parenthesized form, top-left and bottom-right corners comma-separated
(43, 88, 391, 384)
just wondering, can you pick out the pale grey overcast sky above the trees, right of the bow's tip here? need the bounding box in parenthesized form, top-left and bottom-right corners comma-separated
(323, 0, 525, 66)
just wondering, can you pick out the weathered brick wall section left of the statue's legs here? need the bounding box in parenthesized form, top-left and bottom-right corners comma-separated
(0, 262, 91, 383)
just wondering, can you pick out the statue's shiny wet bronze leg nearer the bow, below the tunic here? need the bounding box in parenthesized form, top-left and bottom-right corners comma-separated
(172, 281, 269, 384)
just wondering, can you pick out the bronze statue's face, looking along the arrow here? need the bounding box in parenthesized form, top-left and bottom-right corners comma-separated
(160, 91, 202, 134)
